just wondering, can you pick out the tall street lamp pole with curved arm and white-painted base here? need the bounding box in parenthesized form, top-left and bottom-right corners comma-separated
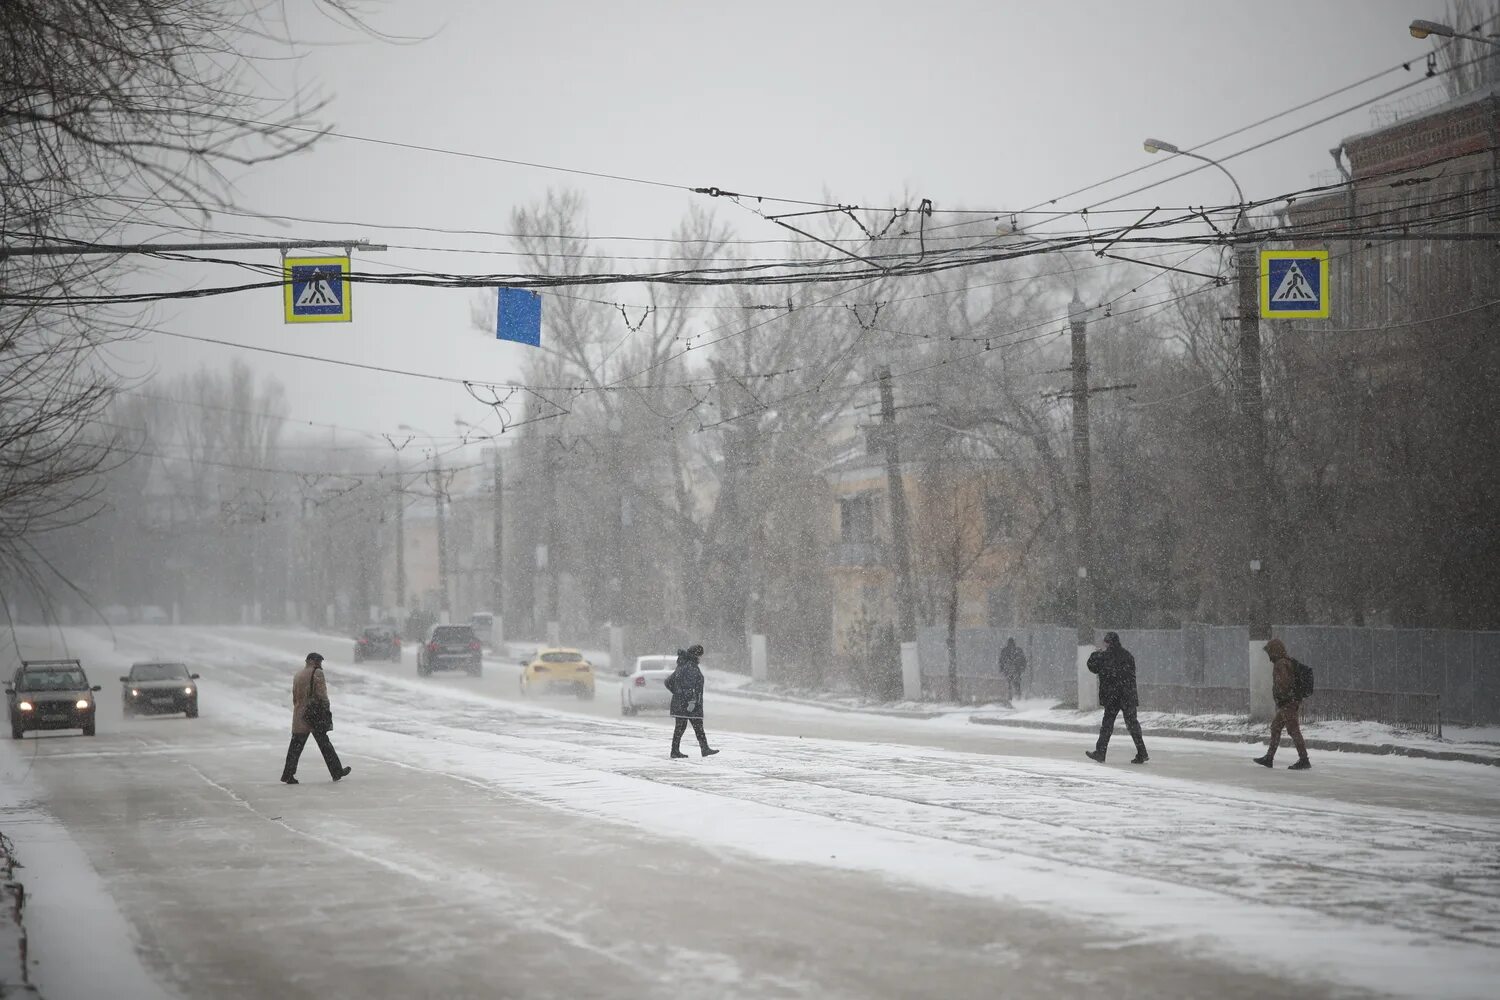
(1145, 139, 1271, 717)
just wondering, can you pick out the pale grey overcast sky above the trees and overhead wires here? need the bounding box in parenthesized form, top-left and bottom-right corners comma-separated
(114, 0, 1445, 458)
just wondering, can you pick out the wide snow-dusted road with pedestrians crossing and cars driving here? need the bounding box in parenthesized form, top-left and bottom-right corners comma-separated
(0, 628, 1500, 1000)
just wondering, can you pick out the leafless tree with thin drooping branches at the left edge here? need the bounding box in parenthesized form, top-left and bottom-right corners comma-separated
(0, 0, 381, 602)
